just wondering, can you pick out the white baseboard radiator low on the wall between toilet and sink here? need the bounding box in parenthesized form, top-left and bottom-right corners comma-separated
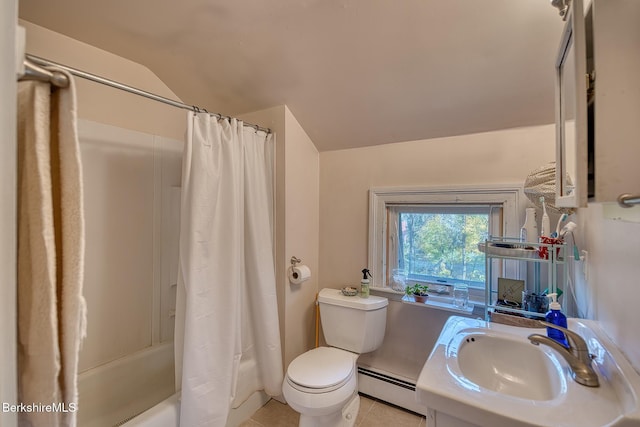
(358, 366, 427, 416)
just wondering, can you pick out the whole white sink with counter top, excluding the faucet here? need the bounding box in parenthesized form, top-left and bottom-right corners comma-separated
(416, 316, 640, 427)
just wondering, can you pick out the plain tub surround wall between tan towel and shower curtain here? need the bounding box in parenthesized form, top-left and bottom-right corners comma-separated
(78, 120, 183, 372)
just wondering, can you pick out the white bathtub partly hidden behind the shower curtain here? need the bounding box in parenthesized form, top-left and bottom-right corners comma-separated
(78, 342, 270, 427)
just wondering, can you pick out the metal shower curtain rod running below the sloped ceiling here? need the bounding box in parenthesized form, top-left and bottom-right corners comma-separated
(25, 54, 271, 133)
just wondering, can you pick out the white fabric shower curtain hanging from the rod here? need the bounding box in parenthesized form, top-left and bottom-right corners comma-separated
(175, 113, 283, 427)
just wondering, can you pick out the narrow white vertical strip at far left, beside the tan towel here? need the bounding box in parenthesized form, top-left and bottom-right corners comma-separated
(0, 0, 18, 427)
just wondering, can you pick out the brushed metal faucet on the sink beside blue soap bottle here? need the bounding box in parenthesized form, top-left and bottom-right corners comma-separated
(528, 320, 600, 387)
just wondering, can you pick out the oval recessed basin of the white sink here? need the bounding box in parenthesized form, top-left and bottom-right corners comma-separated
(447, 331, 566, 400)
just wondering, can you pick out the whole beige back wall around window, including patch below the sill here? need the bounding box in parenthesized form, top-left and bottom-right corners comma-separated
(320, 125, 555, 381)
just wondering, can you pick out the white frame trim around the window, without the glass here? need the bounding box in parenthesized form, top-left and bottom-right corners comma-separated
(368, 184, 523, 292)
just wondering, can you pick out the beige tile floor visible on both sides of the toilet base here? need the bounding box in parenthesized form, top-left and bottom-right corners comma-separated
(240, 396, 426, 427)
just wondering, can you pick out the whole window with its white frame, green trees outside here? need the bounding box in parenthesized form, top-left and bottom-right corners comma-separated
(369, 187, 519, 289)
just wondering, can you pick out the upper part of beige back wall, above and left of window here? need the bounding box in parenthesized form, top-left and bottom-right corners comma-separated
(320, 125, 555, 288)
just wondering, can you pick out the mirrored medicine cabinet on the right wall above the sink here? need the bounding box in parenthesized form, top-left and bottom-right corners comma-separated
(555, 0, 640, 208)
